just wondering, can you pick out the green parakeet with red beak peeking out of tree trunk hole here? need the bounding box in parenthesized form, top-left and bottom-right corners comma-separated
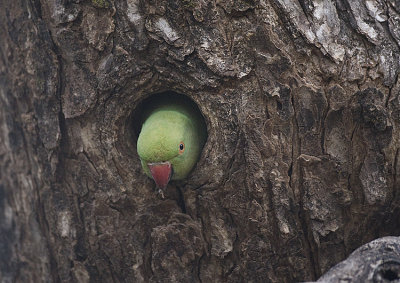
(137, 96, 207, 194)
